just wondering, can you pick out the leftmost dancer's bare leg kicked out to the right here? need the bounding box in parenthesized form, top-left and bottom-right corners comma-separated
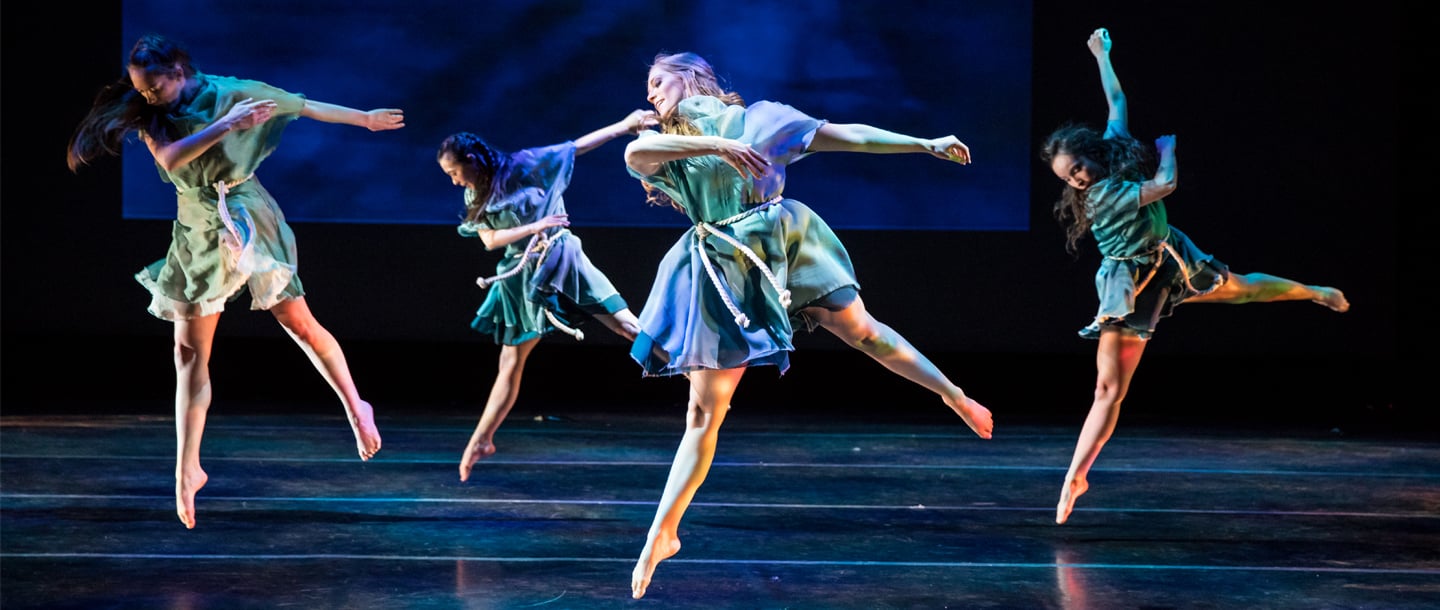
(271, 296, 380, 460)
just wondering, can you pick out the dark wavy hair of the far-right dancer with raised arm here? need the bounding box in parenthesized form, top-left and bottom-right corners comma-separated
(1040, 124, 1149, 255)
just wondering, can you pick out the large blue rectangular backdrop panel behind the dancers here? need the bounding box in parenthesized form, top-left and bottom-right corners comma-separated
(117, 0, 1035, 232)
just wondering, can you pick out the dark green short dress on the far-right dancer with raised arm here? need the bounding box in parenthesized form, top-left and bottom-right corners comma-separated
(1080, 164, 1230, 340)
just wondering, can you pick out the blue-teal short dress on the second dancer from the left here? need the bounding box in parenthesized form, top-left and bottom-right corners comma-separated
(458, 141, 628, 345)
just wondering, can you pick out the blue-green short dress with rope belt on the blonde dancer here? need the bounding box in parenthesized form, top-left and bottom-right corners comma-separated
(629, 95, 860, 377)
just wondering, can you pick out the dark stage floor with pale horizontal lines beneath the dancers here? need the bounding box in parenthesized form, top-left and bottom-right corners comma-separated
(0, 404, 1440, 610)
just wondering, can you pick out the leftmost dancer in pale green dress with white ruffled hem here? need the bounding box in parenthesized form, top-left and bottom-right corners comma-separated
(66, 35, 405, 528)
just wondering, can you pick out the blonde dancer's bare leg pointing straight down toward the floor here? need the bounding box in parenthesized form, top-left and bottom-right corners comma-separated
(631, 363, 744, 600)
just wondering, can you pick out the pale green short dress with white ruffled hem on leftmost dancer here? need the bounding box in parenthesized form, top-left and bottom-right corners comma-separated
(135, 72, 305, 321)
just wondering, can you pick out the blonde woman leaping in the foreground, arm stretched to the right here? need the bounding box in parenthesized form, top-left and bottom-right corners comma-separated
(625, 53, 992, 598)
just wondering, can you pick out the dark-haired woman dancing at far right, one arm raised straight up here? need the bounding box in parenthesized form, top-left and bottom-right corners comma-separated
(1041, 27, 1349, 524)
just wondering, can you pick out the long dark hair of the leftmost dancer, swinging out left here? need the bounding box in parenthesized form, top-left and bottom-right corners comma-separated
(65, 35, 194, 171)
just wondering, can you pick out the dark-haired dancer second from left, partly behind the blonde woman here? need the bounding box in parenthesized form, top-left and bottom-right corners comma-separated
(436, 111, 655, 481)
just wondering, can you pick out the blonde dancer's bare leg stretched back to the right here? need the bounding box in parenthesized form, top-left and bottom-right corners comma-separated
(806, 296, 995, 439)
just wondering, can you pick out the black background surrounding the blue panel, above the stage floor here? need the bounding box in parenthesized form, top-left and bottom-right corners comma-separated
(0, 1, 1416, 433)
